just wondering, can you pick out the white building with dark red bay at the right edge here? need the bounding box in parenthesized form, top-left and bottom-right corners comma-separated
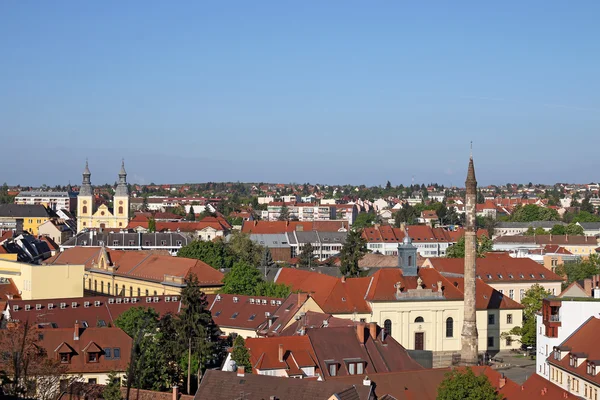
(536, 294, 600, 382)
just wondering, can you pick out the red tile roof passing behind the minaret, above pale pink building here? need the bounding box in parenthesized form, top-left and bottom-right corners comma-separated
(424, 252, 563, 283)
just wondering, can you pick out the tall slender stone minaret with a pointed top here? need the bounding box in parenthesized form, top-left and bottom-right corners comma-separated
(460, 150, 479, 365)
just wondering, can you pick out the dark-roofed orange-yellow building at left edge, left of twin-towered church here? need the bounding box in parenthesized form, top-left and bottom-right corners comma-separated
(0, 204, 55, 236)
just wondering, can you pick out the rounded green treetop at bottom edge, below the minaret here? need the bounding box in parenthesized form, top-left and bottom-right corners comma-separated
(437, 368, 503, 400)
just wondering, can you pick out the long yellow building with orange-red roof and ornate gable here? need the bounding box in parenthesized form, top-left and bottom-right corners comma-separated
(44, 247, 223, 297)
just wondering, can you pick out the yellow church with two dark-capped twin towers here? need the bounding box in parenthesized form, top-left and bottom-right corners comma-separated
(77, 161, 129, 232)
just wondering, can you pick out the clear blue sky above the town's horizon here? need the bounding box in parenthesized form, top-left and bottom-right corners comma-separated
(0, 0, 600, 185)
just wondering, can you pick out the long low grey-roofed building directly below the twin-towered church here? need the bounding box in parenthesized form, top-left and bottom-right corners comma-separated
(60, 230, 194, 256)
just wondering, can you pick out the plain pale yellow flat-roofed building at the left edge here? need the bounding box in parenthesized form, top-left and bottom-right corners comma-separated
(0, 259, 85, 300)
